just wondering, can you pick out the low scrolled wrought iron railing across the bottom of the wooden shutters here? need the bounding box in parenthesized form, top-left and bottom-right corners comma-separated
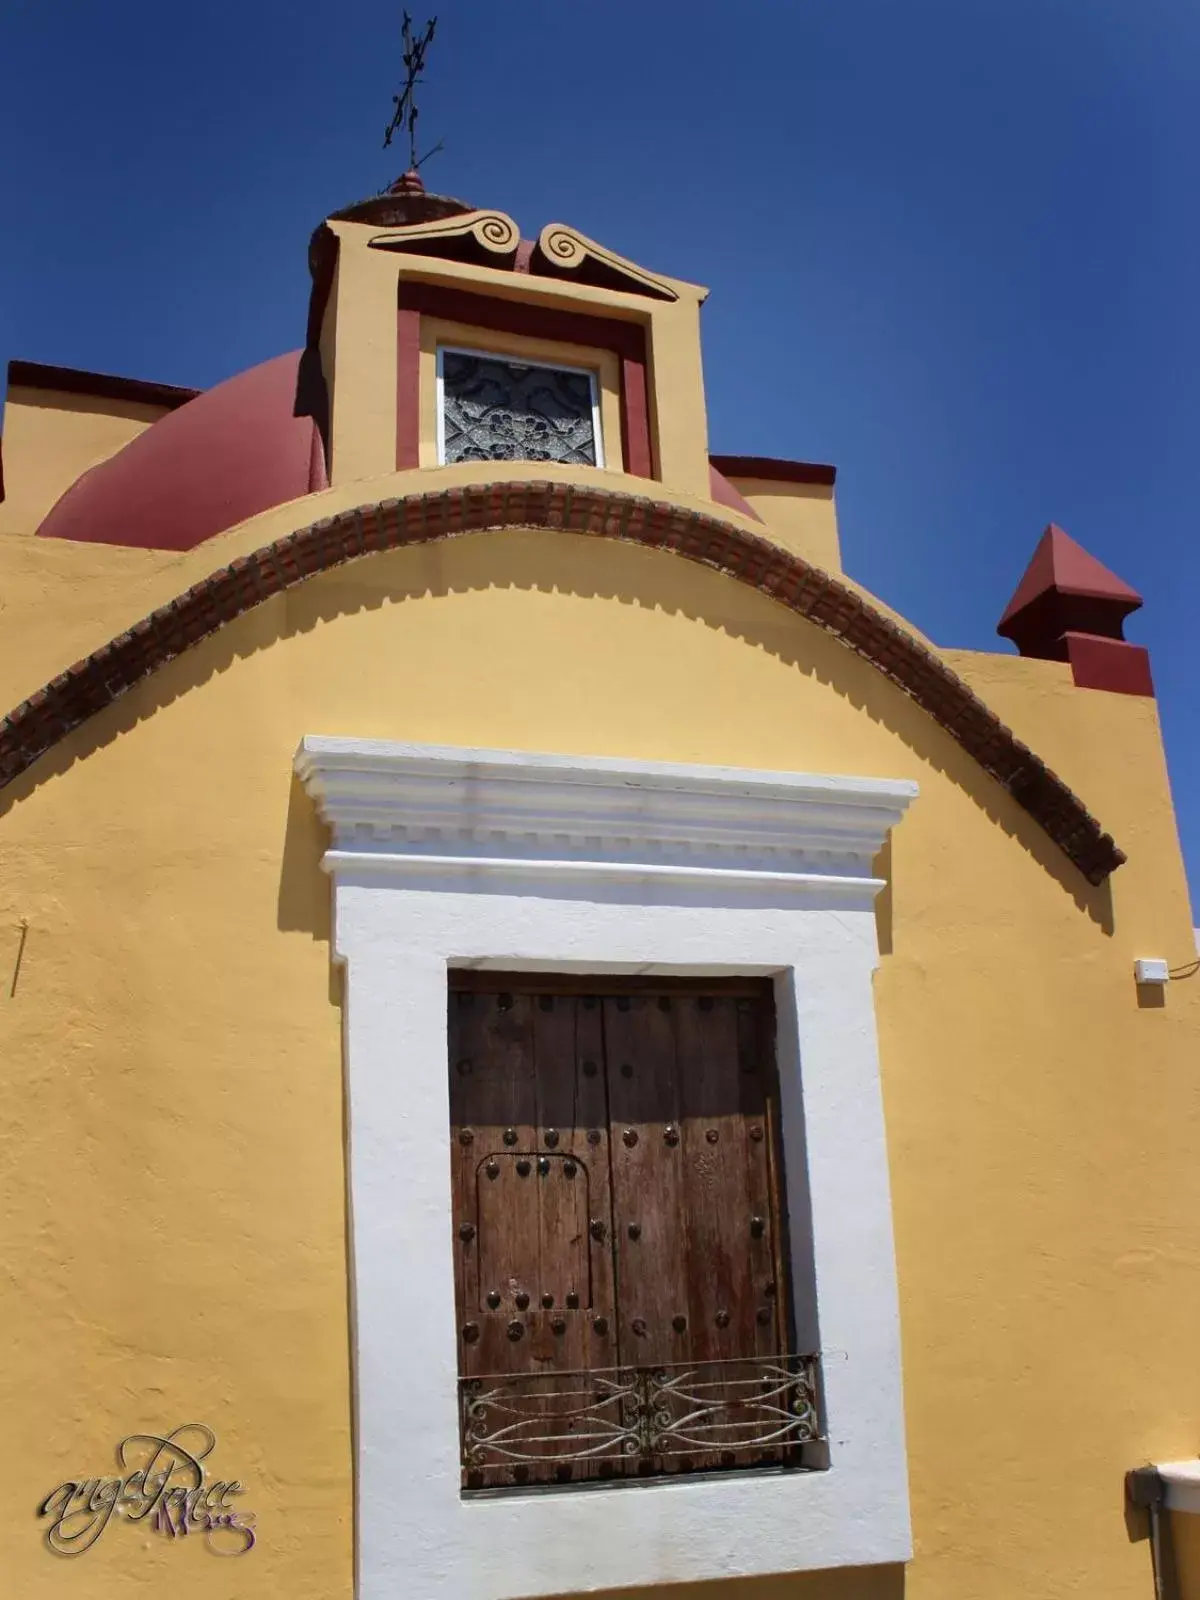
(459, 1355, 821, 1488)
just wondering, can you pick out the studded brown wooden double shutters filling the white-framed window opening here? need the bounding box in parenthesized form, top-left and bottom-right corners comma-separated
(450, 973, 816, 1488)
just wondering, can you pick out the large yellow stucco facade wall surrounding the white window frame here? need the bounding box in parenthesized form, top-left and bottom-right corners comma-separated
(0, 515, 1200, 1600)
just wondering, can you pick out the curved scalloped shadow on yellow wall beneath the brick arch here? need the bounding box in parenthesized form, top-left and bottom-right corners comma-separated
(0, 531, 1112, 938)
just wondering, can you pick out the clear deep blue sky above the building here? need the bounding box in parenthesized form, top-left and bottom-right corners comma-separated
(0, 0, 1200, 908)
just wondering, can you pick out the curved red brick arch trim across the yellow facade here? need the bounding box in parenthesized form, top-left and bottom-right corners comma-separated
(0, 483, 1125, 883)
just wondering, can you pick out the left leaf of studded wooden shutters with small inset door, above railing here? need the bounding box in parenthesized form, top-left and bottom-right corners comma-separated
(450, 989, 618, 1378)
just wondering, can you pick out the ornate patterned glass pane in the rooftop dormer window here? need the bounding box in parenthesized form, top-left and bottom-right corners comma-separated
(442, 350, 597, 467)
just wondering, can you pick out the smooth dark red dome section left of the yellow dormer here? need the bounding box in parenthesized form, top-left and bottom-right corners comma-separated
(37, 350, 328, 550)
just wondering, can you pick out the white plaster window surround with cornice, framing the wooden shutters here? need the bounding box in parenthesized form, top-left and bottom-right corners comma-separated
(296, 738, 915, 1600)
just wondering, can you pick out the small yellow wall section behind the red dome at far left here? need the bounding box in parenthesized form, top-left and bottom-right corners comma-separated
(0, 386, 166, 534)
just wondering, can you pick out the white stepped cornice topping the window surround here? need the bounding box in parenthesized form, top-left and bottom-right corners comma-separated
(296, 734, 917, 894)
